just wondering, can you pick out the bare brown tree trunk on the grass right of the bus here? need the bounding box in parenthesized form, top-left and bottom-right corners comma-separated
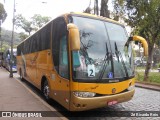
(143, 44, 154, 81)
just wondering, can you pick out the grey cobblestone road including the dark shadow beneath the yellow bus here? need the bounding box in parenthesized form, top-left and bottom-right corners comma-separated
(13, 72, 160, 120)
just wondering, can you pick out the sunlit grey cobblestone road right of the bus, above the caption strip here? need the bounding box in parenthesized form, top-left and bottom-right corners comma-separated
(107, 88, 160, 111)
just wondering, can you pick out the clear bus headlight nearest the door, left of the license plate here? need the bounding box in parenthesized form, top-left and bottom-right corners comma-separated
(73, 91, 96, 98)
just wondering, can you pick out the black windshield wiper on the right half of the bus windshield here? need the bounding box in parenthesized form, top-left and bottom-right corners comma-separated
(115, 42, 129, 78)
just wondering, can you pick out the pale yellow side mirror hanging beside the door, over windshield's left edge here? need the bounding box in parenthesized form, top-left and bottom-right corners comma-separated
(67, 23, 80, 51)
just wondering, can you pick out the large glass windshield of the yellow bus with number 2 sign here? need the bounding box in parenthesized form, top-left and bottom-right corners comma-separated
(72, 16, 134, 82)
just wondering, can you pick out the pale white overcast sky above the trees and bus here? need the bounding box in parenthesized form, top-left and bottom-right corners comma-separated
(0, 0, 94, 30)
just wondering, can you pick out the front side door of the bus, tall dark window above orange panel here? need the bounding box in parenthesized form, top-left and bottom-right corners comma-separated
(52, 17, 70, 109)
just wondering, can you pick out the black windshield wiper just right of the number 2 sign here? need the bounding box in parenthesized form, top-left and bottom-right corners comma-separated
(98, 42, 112, 82)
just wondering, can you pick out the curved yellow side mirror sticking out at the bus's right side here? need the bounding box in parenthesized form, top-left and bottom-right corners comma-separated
(130, 35, 148, 56)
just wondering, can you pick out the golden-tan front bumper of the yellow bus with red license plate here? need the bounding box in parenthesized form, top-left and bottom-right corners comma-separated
(70, 90, 135, 111)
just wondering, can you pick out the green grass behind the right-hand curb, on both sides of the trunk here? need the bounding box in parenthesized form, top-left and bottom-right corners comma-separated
(136, 72, 160, 84)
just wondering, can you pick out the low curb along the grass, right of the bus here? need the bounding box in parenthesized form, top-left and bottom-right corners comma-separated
(135, 81, 160, 91)
